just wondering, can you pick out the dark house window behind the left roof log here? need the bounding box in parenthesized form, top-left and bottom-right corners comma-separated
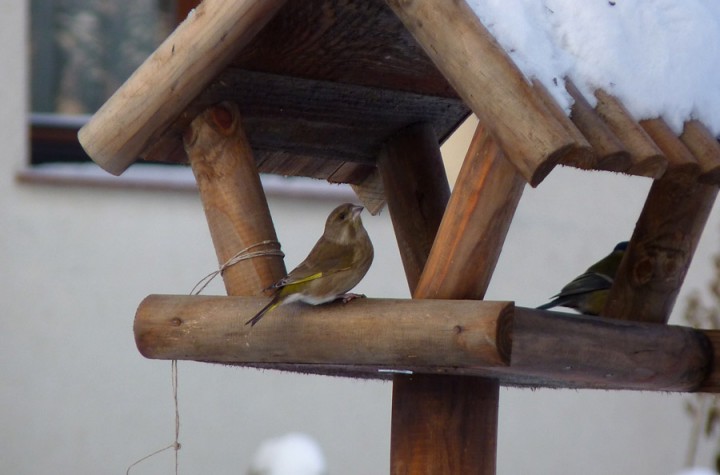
(29, 0, 181, 165)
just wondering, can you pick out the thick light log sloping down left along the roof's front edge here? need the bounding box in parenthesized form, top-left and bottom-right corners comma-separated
(78, 0, 285, 175)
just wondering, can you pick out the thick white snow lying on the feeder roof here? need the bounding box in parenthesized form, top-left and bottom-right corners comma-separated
(468, 0, 720, 136)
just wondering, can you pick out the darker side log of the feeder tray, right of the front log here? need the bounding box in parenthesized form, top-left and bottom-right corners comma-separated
(511, 308, 712, 391)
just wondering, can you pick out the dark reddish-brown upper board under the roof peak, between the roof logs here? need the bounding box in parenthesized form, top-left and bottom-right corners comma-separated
(232, 0, 458, 99)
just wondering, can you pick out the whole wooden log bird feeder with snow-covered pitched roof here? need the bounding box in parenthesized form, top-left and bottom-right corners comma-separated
(79, 0, 720, 475)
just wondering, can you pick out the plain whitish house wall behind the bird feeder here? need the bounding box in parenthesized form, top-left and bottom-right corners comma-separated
(5, 2, 720, 475)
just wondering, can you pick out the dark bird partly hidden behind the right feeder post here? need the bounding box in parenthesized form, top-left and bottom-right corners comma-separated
(538, 241, 628, 315)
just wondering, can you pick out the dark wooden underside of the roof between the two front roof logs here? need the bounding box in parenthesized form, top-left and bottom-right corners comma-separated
(86, 0, 470, 183)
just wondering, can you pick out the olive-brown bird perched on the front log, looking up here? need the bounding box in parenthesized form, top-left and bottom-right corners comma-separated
(245, 203, 374, 326)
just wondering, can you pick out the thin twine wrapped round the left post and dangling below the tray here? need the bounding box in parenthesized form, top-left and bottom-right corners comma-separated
(125, 239, 285, 475)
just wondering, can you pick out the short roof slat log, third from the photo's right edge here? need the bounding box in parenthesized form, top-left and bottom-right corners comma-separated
(595, 89, 667, 178)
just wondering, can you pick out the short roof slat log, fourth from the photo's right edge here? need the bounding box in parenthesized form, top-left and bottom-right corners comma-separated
(563, 79, 631, 172)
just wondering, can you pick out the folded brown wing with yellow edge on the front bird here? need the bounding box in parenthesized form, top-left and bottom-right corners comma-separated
(273, 238, 355, 288)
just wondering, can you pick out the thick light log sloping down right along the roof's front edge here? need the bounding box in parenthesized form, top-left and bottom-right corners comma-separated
(386, 0, 589, 186)
